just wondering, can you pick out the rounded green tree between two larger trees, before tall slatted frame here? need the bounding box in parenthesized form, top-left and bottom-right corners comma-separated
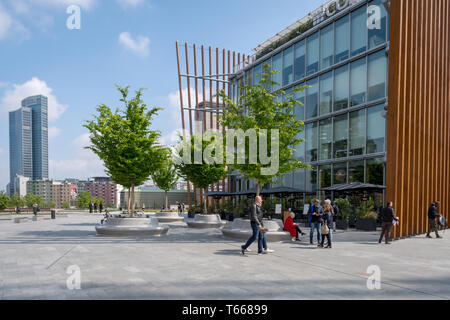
(175, 136, 227, 214)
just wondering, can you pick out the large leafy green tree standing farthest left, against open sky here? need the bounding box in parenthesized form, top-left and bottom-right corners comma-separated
(84, 86, 165, 217)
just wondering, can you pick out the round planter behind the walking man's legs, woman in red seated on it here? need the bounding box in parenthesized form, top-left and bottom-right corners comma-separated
(222, 219, 292, 242)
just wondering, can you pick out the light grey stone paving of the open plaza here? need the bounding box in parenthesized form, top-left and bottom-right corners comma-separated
(0, 213, 450, 300)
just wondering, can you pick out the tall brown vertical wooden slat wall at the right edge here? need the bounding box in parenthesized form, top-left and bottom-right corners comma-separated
(386, 0, 450, 237)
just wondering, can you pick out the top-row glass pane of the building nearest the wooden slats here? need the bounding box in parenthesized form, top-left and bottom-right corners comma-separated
(368, 0, 387, 49)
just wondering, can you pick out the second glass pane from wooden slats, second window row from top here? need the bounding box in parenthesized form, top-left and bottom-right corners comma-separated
(350, 58, 367, 106)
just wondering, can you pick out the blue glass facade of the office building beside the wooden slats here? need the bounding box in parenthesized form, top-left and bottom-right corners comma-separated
(231, 0, 389, 197)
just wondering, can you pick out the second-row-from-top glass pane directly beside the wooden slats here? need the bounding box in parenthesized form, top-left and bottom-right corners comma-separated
(368, 50, 386, 101)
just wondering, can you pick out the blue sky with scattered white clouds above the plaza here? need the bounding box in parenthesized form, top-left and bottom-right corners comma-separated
(0, 0, 325, 190)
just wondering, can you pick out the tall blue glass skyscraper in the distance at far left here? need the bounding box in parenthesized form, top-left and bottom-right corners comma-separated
(9, 95, 48, 195)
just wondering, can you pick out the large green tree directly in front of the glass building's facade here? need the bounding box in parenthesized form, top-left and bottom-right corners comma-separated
(219, 63, 310, 195)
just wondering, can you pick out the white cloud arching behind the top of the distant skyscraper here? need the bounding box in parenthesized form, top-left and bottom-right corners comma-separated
(0, 77, 68, 121)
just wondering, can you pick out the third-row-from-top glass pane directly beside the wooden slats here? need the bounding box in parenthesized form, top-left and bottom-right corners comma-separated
(367, 105, 386, 153)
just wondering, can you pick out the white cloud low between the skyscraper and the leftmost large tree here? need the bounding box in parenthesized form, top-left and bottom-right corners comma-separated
(49, 133, 105, 179)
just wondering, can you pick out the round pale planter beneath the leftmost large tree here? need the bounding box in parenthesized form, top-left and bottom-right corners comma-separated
(95, 218, 169, 237)
